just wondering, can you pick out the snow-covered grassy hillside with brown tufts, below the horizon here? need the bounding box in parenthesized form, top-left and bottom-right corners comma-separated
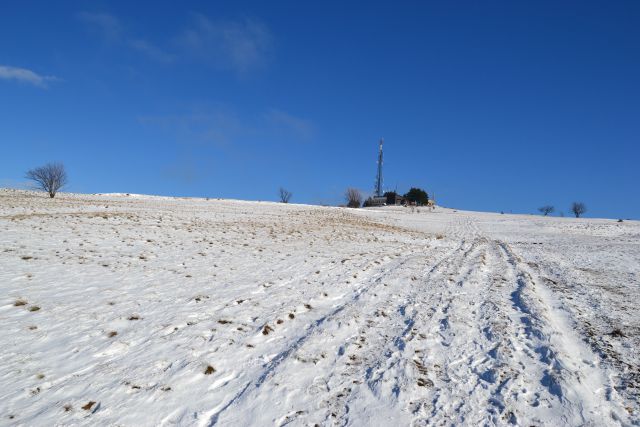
(0, 190, 640, 426)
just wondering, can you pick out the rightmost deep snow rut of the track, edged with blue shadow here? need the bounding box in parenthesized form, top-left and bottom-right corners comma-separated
(495, 242, 624, 426)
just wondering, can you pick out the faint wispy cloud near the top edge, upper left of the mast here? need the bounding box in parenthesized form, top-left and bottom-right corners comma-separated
(177, 14, 273, 74)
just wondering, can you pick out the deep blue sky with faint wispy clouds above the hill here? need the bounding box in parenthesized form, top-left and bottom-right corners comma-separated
(0, 1, 640, 218)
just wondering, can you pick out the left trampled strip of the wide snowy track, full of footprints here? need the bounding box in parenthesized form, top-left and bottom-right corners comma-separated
(407, 238, 500, 425)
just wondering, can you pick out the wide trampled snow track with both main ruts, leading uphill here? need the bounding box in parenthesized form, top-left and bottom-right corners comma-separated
(398, 222, 617, 425)
